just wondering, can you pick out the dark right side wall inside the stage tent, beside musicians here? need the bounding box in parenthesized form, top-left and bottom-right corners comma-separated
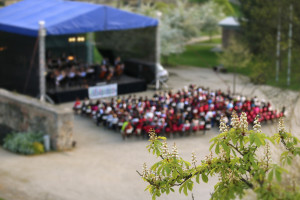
(95, 27, 156, 83)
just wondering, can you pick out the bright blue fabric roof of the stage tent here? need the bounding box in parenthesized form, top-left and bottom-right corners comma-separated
(0, 0, 158, 36)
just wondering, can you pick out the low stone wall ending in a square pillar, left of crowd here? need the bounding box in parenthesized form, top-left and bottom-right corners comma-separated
(0, 89, 74, 150)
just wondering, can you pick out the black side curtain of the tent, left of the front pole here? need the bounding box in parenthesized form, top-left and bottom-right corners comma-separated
(0, 32, 39, 96)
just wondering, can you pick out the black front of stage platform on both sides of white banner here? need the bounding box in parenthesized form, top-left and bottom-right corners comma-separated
(47, 75, 147, 104)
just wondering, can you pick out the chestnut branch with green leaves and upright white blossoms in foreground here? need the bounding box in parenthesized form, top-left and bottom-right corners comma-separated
(138, 113, 300, 199)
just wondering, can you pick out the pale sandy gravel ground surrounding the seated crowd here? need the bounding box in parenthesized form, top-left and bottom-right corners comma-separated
(0, 67, 300, 200)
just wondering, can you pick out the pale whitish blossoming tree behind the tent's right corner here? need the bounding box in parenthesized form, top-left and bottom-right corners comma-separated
(123, 0, 224, 63)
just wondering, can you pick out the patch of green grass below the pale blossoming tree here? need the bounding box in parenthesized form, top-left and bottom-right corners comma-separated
(168, 39, 221, 67)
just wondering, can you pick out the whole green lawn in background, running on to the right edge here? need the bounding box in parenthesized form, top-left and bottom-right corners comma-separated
(164, 39, 300, 90)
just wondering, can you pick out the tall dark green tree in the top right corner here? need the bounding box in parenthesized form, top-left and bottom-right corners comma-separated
(239, 0, 300, 85)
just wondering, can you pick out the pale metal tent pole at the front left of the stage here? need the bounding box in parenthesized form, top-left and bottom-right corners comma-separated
(38, 21, 46, 101)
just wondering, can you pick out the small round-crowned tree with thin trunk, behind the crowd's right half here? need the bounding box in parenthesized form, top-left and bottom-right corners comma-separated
(218, 39, 252, 94)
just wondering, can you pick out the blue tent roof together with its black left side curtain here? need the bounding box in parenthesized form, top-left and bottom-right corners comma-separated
(0, 0, 158, 101)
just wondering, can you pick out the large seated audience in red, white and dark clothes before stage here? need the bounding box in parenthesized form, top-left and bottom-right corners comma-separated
(73, 85, 285, 138)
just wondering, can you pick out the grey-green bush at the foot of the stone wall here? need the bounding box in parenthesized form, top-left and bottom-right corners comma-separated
(3, 132, 44, 155)
